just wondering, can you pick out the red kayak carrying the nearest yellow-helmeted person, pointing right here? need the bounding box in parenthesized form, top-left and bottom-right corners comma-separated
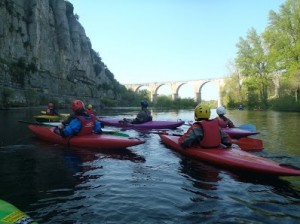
(160, 135, 300, 176)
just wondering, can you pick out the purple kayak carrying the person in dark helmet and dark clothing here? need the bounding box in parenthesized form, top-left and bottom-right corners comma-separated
(99, 117, 184, 129)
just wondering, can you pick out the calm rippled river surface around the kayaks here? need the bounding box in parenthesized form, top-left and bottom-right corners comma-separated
(0, 109, 300, 224)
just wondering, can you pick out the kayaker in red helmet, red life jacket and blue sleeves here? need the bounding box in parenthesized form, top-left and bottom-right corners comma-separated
(54, 100, 102, 137)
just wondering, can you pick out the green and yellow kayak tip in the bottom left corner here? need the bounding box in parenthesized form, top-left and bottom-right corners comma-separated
(0, 199, 37, 224)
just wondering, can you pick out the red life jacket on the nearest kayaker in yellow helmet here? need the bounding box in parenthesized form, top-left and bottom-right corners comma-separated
(199, 119, 222, 148)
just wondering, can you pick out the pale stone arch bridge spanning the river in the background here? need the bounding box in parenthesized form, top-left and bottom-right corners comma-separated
(125, 79, 224, 105)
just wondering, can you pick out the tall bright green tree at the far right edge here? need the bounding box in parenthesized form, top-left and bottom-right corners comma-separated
(263, 0, 300, 101)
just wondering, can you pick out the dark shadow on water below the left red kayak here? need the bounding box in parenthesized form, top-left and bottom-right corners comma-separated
(0, 139, 145, 211)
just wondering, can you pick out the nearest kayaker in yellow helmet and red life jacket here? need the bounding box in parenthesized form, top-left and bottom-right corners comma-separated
(179, 104, 232, 148)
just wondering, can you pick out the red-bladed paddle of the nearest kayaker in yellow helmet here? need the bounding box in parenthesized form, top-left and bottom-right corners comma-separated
(149, 131, 263, 151)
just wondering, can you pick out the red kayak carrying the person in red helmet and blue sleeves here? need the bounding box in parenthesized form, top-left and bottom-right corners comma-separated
(28, 125, 145, 149)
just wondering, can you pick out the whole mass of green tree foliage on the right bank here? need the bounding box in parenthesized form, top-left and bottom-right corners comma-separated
(222, 0, 300, 108)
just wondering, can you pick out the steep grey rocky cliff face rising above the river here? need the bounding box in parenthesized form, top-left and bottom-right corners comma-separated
(0, 0, 119, 105)
